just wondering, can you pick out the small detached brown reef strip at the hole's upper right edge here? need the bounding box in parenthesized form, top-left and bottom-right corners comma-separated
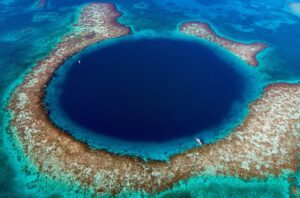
(180, 22, 267, 66)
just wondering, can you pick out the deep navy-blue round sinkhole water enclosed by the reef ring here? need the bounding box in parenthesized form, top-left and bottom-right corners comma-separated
(47, 39, 244, 142)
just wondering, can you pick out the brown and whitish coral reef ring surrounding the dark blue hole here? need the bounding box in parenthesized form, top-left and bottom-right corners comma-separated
(9, 3, 300, 194)
